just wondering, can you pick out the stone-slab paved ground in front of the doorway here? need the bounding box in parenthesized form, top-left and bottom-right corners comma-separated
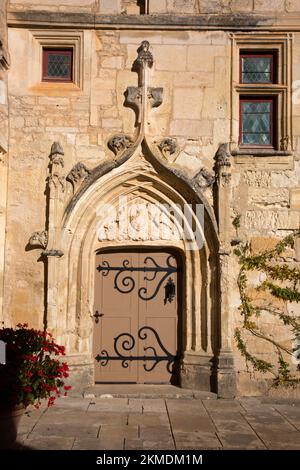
(18, 397, 300, 450)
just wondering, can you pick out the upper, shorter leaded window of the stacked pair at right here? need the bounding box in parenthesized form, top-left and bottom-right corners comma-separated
(240, 51, 276, 83)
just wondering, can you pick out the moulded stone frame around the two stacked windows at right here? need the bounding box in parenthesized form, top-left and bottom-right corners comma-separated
(230, 33, 293, 163)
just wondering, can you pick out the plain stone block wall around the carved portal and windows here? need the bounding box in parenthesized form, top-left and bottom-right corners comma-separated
(0, 0, 300, 394)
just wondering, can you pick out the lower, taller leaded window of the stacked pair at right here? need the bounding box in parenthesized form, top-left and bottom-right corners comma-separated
(240, 98, 274, 147)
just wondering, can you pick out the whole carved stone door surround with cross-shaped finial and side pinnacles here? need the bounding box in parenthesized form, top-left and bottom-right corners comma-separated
(29, 41, 235, 397)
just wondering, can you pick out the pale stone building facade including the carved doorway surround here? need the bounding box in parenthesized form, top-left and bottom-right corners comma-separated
(0, 0, 300, 397)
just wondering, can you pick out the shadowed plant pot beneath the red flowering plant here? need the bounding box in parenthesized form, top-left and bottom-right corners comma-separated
(0, 405, 25, 449)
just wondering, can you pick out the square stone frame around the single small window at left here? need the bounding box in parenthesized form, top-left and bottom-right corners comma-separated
(31, 30, 83, 91)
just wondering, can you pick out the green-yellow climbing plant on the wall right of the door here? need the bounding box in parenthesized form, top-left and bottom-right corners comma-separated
(234, 230, 300, 385)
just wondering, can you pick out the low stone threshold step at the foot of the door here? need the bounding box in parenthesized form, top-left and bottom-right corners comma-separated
(80, 383, 217, 400)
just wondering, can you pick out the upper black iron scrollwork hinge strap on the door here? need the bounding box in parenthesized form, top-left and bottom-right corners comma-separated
(97, 255, 180, 300)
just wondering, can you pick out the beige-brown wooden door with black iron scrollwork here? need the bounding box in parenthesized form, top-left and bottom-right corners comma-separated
(94, 251, 180, 383)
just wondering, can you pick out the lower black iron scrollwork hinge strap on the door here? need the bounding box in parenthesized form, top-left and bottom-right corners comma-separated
(95, 326, 178, 374)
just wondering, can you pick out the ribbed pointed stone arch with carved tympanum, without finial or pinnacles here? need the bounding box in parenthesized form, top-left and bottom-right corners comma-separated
(56, 151, 219, 390)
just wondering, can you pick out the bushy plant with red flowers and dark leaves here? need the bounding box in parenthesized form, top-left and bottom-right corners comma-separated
(0, 323, 71, 408)
